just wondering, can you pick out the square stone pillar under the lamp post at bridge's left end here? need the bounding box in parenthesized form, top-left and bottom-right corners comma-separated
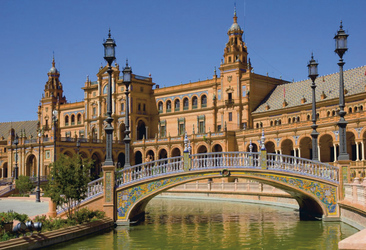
(102, 165, 116, 220)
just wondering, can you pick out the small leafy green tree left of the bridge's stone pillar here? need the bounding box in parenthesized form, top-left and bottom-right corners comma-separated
(46, 155, 93, 218)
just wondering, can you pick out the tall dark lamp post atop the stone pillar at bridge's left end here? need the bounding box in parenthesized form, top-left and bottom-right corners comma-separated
(103, 30, 116, 166)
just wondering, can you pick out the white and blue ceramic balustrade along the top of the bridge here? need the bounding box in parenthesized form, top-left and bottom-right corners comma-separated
(116, 152, 339, 187)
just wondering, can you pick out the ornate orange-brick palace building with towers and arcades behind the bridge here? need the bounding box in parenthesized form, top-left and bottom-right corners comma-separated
(0, 13, 366, 178)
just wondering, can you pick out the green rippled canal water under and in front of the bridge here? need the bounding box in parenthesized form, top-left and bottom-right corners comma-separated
(53, 198, 358, 249)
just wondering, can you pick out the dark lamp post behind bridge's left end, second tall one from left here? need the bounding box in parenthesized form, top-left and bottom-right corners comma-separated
(122, 60, 132, 168)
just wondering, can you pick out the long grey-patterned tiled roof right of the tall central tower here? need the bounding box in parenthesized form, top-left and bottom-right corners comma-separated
(253, 66, 366, 114)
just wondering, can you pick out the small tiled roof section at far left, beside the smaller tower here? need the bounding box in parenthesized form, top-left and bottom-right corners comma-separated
(0, 120, 38, 139)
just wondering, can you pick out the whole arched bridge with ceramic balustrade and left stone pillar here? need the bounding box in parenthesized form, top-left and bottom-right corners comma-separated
(63, 151, 341, 224)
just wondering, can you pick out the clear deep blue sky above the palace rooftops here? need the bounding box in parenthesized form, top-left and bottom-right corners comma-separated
(0, 0, 366, 122)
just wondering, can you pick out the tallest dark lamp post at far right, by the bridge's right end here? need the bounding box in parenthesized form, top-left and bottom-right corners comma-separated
(334, 21, 349, 161)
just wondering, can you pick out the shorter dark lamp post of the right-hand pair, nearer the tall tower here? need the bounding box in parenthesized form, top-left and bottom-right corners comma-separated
(308, 54, 319, 161)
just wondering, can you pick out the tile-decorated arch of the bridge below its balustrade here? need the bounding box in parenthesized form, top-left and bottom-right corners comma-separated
(116, 169, 339, 224)
